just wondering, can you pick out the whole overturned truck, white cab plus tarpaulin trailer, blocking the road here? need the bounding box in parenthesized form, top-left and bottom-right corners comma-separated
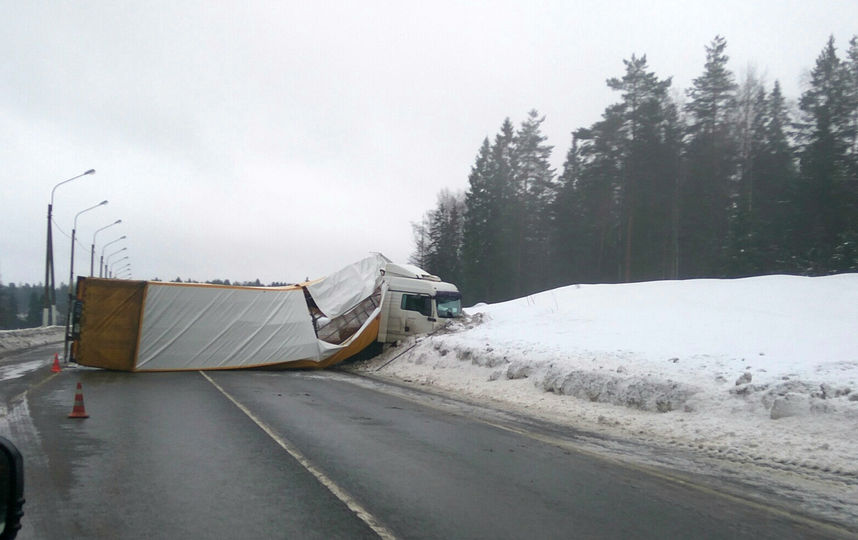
(69, 255, 461, 371)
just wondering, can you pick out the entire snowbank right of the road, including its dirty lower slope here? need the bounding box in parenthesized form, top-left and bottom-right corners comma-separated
(353, 274, 858, 516)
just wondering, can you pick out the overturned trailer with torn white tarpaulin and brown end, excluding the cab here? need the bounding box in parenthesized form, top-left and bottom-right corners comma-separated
(76, 255, 387, 371)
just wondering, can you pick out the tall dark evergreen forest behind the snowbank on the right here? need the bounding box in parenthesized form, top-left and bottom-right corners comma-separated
(411, 36, 858, 303)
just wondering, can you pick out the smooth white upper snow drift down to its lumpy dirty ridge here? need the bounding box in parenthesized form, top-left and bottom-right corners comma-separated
(454, 274, 858, 417)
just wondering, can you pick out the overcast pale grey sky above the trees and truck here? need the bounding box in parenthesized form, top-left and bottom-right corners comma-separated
(0, 0, 858, 283)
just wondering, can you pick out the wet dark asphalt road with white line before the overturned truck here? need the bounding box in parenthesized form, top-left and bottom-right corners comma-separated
(0, 348, 848, 539)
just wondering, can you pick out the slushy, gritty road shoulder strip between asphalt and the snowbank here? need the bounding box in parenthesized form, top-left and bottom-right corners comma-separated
(339, 360, 858, 537)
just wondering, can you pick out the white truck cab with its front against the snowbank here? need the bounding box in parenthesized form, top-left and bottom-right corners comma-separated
(378, 262, 462, 343)
